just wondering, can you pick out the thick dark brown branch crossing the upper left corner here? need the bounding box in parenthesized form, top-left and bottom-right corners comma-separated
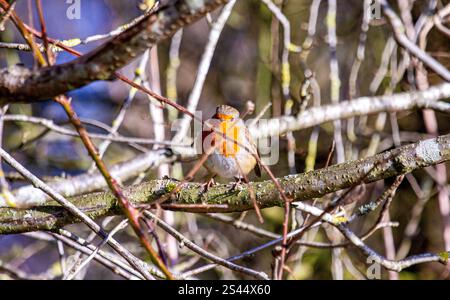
(0, 0, 227, 104)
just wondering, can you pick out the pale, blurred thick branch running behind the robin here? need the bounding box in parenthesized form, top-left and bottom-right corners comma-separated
(0, 83, 450, 207)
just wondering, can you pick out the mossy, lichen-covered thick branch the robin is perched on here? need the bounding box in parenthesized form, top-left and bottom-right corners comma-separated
(0, 135, 450, 234)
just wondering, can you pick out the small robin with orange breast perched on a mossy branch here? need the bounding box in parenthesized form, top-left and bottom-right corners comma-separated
(202, 105, 261, 189)
